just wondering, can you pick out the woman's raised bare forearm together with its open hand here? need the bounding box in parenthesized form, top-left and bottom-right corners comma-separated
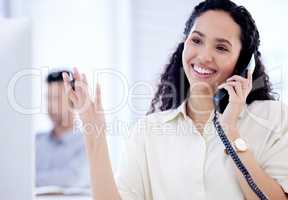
(63, 68, 120, 200)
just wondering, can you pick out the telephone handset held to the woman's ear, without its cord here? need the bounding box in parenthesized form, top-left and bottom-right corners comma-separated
(213, 54, 255, 113)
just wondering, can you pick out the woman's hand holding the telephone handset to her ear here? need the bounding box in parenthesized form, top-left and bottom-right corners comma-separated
(218, 70, 252, 128)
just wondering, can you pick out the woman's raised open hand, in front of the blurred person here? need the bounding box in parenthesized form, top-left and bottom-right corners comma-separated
(63, 68, 106, 135)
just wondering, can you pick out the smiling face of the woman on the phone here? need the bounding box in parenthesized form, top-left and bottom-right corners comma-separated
(182, 11, 241, 91)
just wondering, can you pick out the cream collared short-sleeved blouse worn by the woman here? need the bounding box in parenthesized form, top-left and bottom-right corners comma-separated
(116, 100, 288, 200)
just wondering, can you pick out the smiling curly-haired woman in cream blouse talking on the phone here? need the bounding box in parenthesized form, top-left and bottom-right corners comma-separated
(64, 0, 288, 200)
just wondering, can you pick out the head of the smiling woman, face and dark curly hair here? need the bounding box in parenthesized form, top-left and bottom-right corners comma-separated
(149, 1, 275, 113)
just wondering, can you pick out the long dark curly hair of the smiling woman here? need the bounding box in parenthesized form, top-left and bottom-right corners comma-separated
(147, 0, 276, 114)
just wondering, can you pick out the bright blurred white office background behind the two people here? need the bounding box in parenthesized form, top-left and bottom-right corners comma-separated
(0, 0, 288, 172)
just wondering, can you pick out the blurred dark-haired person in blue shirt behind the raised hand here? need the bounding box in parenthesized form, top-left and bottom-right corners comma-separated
(36, 70, 89, 187)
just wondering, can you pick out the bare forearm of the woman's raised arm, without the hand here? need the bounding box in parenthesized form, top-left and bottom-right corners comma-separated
(85, 132, 120, 200)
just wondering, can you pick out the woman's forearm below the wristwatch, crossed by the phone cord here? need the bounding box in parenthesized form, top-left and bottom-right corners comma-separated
(230, 130, 287, 200)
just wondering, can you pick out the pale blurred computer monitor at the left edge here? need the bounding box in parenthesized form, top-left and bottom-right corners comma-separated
(0, 18, 34, 200)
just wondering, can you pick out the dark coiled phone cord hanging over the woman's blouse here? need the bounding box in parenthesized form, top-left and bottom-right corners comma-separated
(213, 110, 268, 200)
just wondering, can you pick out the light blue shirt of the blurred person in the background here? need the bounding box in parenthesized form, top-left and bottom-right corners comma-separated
(36, 130, 90, 187)
